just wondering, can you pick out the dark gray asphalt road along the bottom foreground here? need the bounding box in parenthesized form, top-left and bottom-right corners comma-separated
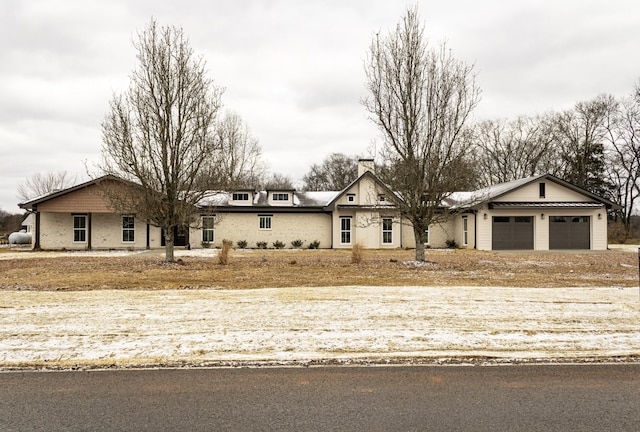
(0, 364, 640, 432)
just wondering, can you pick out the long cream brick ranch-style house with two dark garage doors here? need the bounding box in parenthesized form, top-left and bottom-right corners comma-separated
(20, 159, 619, 250)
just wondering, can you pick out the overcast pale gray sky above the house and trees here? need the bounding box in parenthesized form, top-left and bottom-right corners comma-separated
(0, 0, 640, 212)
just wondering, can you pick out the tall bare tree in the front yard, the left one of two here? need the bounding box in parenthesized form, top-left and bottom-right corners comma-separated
(100, 21, 222, 262)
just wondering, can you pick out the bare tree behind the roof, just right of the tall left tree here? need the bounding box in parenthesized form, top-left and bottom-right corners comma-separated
(213, 113, 266, 190)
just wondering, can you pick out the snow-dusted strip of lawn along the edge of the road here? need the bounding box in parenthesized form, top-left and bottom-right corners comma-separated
(0, 287, 640, 367)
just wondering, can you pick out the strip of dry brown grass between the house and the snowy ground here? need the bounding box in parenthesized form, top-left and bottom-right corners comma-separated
(0, 250, 638, 290)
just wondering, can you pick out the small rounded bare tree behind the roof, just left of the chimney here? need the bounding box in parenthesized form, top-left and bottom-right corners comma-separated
(302, 153, 358, 191)
